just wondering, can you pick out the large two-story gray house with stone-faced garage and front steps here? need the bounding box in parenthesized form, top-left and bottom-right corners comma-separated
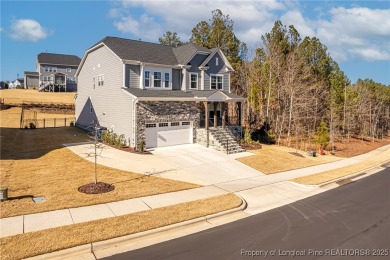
(75, 37, 244, 152)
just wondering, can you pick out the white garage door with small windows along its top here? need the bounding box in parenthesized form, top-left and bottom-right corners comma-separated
(146, 121, 193, 148)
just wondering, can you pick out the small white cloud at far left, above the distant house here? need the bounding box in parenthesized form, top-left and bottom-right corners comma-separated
(10, 19, 48, 42)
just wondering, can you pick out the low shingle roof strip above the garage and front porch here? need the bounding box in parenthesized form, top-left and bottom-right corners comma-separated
(125, 88, 243, 100)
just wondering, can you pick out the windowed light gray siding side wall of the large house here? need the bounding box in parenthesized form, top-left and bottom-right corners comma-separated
(76, 46, 133, 146)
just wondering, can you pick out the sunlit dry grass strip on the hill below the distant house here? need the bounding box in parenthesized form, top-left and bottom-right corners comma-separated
(0, 89, 76, 105)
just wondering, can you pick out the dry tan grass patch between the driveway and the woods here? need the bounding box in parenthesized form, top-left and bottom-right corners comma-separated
(238, 145, 341, 174)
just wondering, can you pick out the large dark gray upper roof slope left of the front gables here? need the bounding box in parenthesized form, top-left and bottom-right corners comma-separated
(101, 36, 178, 65)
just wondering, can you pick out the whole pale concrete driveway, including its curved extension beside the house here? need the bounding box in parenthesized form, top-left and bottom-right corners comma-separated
(65, 143, 264, 185)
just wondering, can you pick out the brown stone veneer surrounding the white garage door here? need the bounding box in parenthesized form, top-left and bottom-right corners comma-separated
(137, 101, 200, 143)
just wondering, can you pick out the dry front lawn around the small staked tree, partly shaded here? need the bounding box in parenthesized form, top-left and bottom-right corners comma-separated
(0, 110, 199, 218)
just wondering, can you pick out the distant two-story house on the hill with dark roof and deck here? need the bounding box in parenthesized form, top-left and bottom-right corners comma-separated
(36, 52, 81, 92)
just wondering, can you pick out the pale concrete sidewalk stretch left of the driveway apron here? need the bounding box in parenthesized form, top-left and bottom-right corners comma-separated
(0, 186, 229, 237)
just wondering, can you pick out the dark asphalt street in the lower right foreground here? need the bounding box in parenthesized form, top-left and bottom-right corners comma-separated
(108, 168, 390, 260)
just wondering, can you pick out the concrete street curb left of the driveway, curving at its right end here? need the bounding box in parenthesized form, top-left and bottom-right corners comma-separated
(25, 193, 248, 260)
